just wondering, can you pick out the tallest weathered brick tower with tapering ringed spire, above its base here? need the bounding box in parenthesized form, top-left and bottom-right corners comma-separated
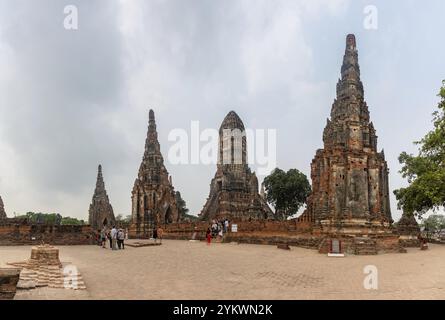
(302, 34, 392, 234)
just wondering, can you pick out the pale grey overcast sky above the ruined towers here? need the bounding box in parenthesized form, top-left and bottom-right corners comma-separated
(0, 0, 445, 220)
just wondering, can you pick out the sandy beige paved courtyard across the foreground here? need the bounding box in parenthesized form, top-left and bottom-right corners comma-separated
(0, 240, 445, 300)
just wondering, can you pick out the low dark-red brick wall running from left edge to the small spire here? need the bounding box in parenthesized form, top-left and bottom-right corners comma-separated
(0, 224, 95, 246)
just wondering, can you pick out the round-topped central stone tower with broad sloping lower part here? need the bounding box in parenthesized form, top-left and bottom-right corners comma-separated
(200, 111, 273, 220)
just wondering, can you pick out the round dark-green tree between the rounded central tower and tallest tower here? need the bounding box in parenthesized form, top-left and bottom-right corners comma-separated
(264, 168, 311, 220)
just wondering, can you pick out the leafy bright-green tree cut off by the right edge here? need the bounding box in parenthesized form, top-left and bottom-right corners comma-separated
(394, 80, 445, 217)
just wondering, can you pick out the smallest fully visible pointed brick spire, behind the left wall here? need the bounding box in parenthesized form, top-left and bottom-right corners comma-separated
(88, 165, 116, 230)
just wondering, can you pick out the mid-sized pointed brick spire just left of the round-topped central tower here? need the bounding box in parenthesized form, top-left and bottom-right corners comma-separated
(131, 110, 181, 236)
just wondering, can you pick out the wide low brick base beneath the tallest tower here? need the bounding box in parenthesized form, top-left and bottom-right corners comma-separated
(318, 218, 406, 255)
